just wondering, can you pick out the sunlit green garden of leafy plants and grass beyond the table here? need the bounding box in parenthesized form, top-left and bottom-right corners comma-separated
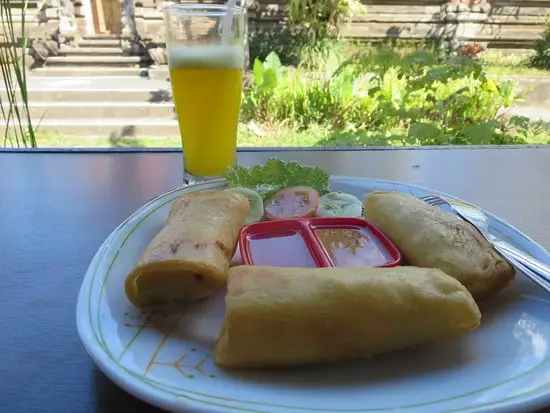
(0, 0, 550, 147)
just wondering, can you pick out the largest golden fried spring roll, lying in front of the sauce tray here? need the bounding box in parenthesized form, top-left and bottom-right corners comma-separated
(215, 266, 481, 368)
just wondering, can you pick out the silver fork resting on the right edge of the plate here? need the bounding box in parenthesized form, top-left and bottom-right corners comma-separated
(420, 195, 550, 292)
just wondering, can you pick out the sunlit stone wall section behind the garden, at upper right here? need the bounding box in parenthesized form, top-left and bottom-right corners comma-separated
(343, 0, 550, 49)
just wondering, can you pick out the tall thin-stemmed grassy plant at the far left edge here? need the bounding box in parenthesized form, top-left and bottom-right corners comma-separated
(0, 0, 36, 147)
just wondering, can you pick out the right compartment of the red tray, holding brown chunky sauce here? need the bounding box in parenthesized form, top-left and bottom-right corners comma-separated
(309, 218, 401, 267)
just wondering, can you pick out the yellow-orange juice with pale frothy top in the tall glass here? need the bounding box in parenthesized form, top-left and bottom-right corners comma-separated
(168, 45, 243, 176)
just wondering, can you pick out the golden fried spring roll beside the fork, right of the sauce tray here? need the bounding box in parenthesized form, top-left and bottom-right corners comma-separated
(365, 192, 515, 299)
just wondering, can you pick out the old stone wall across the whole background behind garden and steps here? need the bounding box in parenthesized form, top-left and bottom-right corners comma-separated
(0, 0, 550, 64)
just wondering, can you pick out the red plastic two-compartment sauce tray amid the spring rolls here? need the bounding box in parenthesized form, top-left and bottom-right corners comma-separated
(239, 218, 401, 267)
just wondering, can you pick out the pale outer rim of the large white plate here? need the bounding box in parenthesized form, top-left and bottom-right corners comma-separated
(76, 175, 550, 413)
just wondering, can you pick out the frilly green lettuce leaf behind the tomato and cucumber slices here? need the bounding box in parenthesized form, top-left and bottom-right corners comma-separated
(225, 158, 329, 200)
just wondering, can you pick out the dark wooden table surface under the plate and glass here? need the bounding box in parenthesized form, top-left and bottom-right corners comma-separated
(0, 148, 550, 413)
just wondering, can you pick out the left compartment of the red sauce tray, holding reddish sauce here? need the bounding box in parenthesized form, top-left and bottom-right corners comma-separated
(239, 219, 330, 268)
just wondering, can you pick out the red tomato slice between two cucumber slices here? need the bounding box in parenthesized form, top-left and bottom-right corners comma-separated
(264, 186, 319, 221)
